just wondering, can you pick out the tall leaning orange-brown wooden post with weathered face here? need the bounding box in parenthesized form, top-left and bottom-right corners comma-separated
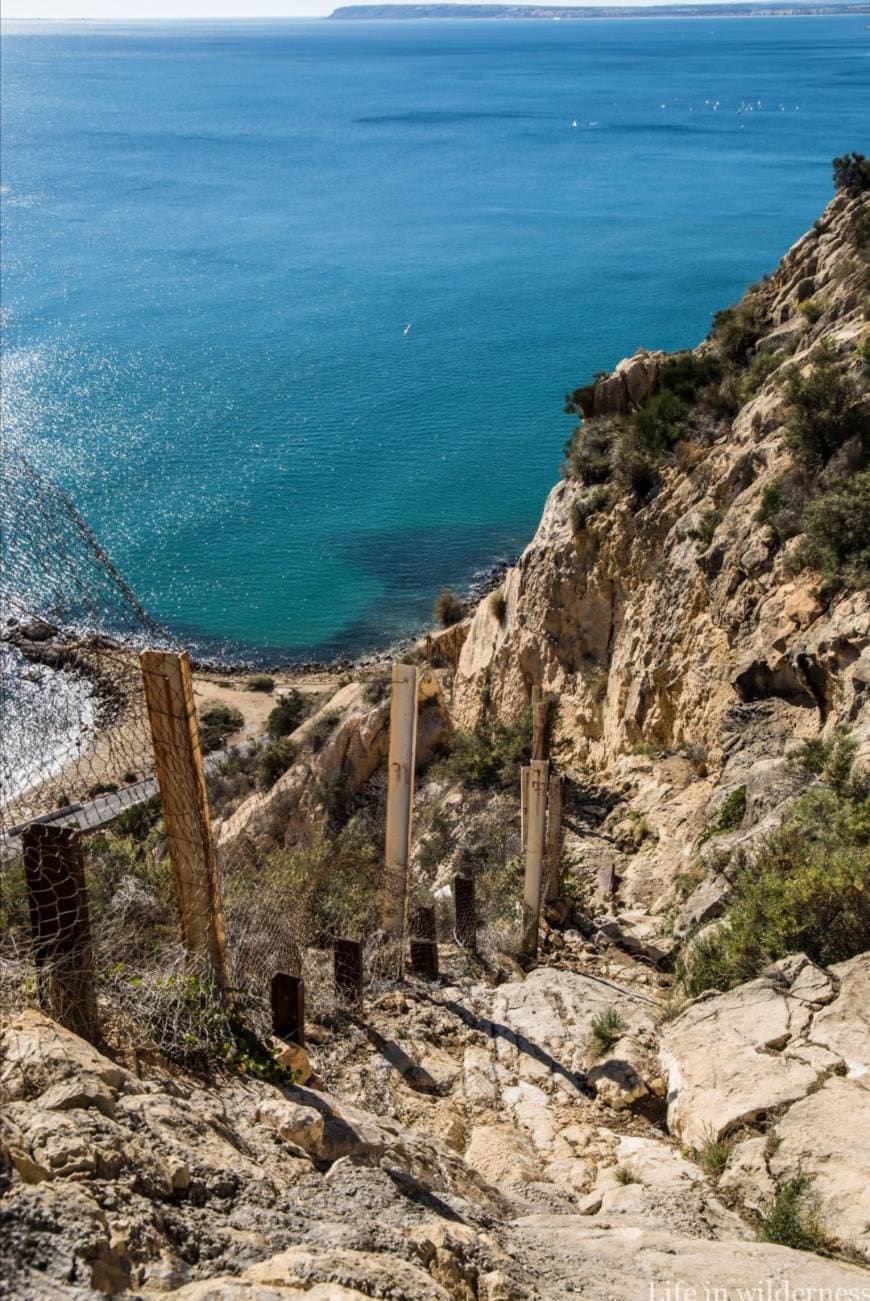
(139, 651, 228, 990)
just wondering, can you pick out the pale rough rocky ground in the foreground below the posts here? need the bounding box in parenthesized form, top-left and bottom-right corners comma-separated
(0, 934, 870, 1301)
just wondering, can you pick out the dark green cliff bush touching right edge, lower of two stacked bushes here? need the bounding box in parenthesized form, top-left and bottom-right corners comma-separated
(789, 470, 870, 591)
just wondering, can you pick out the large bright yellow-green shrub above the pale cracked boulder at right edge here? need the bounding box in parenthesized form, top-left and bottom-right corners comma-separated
(678, 759, 870, 995)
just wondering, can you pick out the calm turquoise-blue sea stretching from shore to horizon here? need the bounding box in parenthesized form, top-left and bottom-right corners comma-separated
(3, 17, 870, 660)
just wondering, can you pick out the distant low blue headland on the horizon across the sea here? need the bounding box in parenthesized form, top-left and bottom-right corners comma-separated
(328, 0, 870, 20)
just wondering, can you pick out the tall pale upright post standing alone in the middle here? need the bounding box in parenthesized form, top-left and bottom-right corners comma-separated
(381, 664, 417, 943)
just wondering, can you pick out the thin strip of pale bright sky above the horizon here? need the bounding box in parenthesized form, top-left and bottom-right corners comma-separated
(3, 0, 821, 20)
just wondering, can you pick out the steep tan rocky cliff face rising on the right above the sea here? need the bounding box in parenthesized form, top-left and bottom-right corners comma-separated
(455, 188, 870, 934)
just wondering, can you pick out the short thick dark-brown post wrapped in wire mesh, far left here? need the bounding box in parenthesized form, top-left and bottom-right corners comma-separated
(21, 822, 100, 1042)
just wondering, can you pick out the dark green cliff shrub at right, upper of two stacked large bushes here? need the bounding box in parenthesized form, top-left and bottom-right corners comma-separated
(785, 346, 866, 471)
